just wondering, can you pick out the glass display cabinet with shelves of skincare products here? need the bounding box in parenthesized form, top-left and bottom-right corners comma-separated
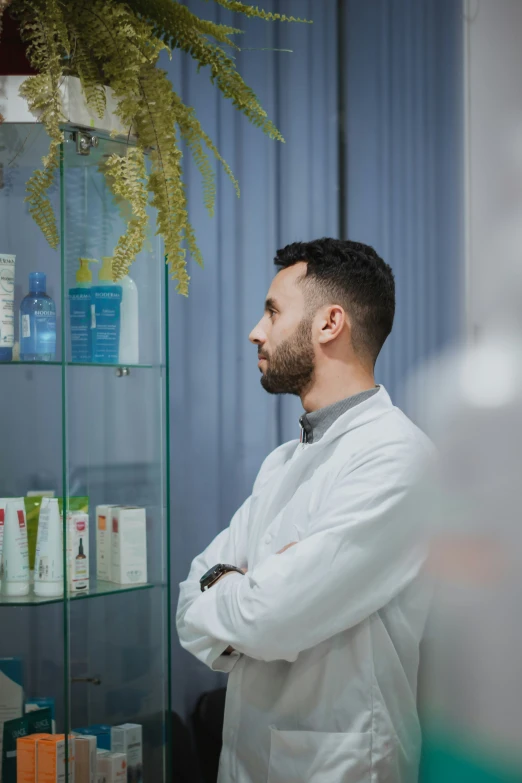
(0, 77, 170, 783)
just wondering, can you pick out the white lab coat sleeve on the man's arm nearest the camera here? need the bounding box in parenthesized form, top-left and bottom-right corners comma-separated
(185, 447, 424, 661)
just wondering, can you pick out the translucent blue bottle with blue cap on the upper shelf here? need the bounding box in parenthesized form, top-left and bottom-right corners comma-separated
(20, 272, 56, 362)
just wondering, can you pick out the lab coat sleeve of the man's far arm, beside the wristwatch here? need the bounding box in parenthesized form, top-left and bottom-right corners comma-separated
(176, 498, 250, 672)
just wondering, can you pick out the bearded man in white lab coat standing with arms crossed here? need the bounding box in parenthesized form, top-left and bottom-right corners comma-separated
(177, 239, 431, 783)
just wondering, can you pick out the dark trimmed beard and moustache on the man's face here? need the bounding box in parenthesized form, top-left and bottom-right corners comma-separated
(259, 317, 315, 397)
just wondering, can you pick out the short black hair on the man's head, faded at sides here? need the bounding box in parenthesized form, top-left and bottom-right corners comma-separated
(274, 237, 395, 364)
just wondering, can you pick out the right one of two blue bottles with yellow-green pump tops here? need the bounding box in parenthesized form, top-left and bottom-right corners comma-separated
(91, 257, 122, 364)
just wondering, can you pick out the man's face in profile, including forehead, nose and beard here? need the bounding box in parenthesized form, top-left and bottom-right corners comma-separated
(250, 262, 315, 396)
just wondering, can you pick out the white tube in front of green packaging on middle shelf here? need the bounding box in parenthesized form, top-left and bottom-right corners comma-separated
(34, 498, 63, 596)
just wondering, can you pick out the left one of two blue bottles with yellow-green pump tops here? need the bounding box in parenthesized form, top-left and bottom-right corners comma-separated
(69, 258, 98, 363)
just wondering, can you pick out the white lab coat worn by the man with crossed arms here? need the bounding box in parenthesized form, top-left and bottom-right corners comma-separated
(177, 387, 431, 783)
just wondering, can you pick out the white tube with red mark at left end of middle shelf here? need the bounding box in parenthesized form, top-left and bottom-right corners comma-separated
(4, 498, 29, 595)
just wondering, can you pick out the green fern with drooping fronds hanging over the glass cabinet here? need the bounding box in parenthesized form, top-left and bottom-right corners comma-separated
(0, 0, 304, 295)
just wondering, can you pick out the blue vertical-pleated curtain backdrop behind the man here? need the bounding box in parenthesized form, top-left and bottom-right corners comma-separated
(163, 0, 462, 713)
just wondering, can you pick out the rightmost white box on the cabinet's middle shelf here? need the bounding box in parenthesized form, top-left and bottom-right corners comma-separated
(111, 506, 147, 585)
